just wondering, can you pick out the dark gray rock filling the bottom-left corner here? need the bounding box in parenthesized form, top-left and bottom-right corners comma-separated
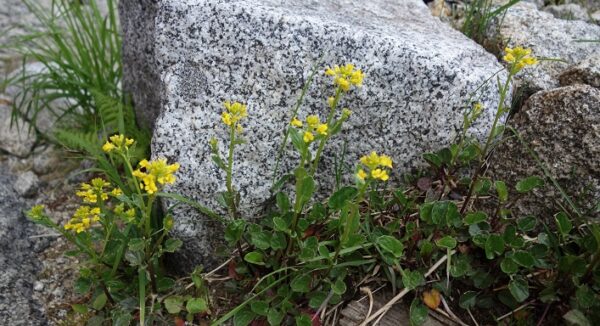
(0, 163, 47, 326)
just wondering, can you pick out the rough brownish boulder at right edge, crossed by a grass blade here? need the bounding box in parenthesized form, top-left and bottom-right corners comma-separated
(490, 85, 600, 219)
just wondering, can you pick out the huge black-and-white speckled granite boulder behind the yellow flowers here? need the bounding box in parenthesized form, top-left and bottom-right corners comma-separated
(121, 0, 505, 268)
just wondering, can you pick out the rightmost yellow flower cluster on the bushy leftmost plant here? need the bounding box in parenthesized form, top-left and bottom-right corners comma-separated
(133, 158, 179, 194)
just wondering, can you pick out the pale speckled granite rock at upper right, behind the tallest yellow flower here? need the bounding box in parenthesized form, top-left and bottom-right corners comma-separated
(492, 3, 600, 91)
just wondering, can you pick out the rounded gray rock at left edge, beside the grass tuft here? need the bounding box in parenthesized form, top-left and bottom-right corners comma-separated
(0, 96, 36, 157)
